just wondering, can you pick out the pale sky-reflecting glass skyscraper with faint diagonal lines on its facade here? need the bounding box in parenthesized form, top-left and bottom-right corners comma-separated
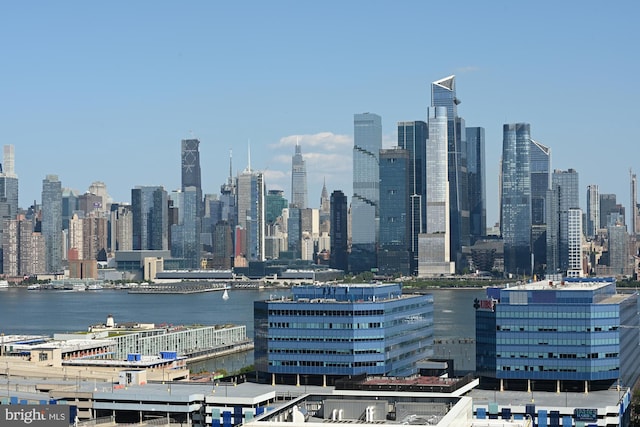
(349, 113, 382, 273)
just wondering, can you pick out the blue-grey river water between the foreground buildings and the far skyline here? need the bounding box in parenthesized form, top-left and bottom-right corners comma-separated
(0, 288, 484, 372)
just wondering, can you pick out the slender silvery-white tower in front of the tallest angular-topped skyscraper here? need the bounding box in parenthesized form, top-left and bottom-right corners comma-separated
(418, 107, 455, 277)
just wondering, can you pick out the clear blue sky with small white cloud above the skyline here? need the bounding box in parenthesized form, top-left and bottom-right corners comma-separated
(0, 0, 640, 224)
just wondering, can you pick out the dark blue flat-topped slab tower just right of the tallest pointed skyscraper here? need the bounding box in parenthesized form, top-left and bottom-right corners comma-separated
(466, 127, 487, 244)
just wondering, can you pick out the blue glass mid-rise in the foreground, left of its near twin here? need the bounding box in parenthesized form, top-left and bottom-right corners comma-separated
(254, 283, 433, 384)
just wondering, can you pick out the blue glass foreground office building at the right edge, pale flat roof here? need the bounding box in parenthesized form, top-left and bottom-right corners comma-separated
(474, 278, 640, 391)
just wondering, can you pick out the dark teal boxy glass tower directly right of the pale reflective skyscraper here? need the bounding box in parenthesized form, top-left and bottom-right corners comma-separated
(378, 147, 413, 276)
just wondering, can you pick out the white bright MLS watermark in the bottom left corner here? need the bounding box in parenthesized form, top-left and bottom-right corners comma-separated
(0, 405, 70, 427)
